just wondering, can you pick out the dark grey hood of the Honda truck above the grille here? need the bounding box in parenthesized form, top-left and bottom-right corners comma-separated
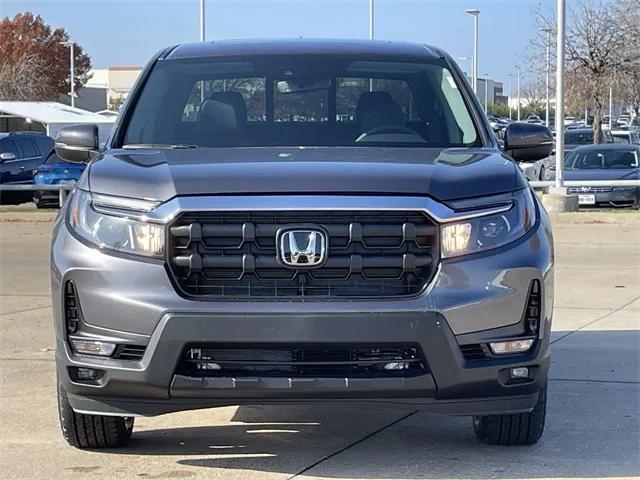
(87, 147, 522, 201)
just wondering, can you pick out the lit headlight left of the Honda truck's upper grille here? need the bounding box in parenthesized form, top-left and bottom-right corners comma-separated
(69, 190, 164, 257)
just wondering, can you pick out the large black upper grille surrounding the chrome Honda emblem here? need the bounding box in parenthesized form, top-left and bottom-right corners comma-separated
(168, 211, 438, 299)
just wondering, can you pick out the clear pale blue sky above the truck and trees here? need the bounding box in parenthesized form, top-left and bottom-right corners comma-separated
(0, 0, 556, 89)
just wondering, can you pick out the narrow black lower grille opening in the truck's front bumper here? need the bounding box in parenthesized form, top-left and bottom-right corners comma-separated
(176, 344, 427, 378)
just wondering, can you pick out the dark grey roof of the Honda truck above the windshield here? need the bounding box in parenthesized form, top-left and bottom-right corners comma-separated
(164, 38, 440, 59)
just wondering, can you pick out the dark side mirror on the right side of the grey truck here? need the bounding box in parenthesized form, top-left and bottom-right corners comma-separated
(504, 122, 553, 163)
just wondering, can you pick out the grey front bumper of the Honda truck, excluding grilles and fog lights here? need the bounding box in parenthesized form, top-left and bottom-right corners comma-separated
(52, 195, 553, 415)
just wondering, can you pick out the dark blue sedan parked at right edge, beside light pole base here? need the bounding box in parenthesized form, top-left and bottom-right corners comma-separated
(549, 143, 640, 208)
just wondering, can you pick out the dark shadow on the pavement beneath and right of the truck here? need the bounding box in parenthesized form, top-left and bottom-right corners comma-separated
(113, 330, 640, 479)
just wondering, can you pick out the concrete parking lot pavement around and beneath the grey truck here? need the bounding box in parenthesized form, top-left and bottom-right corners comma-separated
(0, 211, 640, 480)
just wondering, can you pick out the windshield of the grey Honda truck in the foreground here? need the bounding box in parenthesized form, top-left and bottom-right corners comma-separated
(123, 56, 480, 147)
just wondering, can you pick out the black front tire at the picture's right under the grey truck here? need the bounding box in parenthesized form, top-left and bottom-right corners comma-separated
(473, 385, 547, 445)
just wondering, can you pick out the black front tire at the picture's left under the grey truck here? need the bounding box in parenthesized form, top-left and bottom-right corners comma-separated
(58, 385, 133, 448)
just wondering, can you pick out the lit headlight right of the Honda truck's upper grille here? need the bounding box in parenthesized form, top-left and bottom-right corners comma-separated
(441, 188, 536, 258)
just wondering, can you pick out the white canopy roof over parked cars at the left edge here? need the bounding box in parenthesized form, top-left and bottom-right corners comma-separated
(0, 101, 115, 143)
